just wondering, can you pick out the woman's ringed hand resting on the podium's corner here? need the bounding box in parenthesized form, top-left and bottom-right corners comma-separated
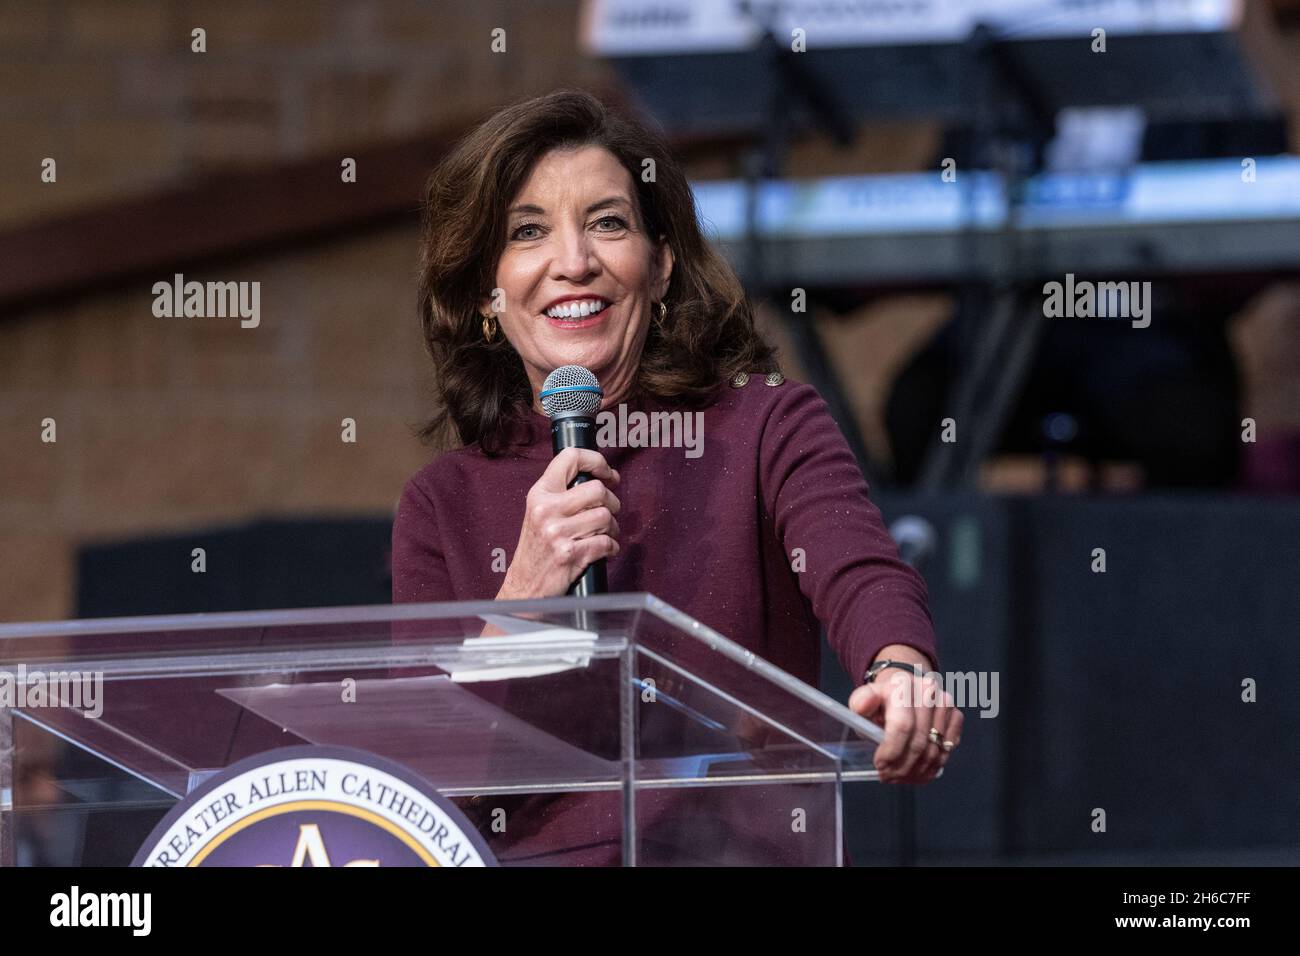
(849, 644, 965, 783)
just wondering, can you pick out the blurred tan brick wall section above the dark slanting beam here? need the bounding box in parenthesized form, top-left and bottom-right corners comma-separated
(0, 0, 601, 225)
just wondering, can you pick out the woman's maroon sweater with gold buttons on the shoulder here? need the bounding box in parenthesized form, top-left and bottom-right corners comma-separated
(393, 375, 939, 862)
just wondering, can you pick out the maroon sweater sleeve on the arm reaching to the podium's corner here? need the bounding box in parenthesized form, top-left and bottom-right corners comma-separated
(759, 382, 939, 683)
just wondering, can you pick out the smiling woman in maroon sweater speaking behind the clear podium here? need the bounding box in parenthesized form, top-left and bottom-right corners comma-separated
(393, 91, 962, 862)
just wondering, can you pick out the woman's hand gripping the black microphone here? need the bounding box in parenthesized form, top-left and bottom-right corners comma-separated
(497, 449, 621, 601)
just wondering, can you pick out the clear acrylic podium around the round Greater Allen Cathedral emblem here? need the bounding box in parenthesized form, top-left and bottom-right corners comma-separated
(0, 593, 883, 866)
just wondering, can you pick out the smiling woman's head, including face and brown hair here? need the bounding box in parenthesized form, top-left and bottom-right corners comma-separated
(419, 85, 776, 455)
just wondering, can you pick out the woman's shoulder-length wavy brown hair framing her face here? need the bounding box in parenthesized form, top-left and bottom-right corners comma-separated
(419, 90, 777, 455)
